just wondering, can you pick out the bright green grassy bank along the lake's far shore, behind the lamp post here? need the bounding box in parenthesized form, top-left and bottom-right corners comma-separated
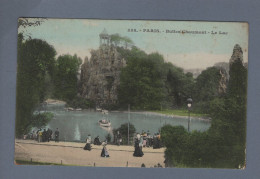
(152, 109, 209, 117)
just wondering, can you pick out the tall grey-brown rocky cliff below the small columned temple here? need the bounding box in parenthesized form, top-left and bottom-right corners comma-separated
(80, 44, 126, 107)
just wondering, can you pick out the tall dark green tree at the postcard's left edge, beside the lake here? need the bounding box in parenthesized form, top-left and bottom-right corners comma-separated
(15, 34, 56, 137)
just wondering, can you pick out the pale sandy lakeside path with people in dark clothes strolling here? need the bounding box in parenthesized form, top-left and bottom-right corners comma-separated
(15, 139, 165, 168)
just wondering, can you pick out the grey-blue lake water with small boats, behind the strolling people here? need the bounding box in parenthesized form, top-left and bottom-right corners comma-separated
(42, 104, 210, 142)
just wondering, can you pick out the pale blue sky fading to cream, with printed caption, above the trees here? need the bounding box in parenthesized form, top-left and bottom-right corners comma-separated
(18, 19, 248, 69)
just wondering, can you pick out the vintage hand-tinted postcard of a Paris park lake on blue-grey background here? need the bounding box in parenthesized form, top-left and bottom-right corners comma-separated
(14, 18, 248, 169)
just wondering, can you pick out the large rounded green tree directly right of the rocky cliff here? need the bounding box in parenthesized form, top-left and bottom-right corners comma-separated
(118, 50, 164, 109)
